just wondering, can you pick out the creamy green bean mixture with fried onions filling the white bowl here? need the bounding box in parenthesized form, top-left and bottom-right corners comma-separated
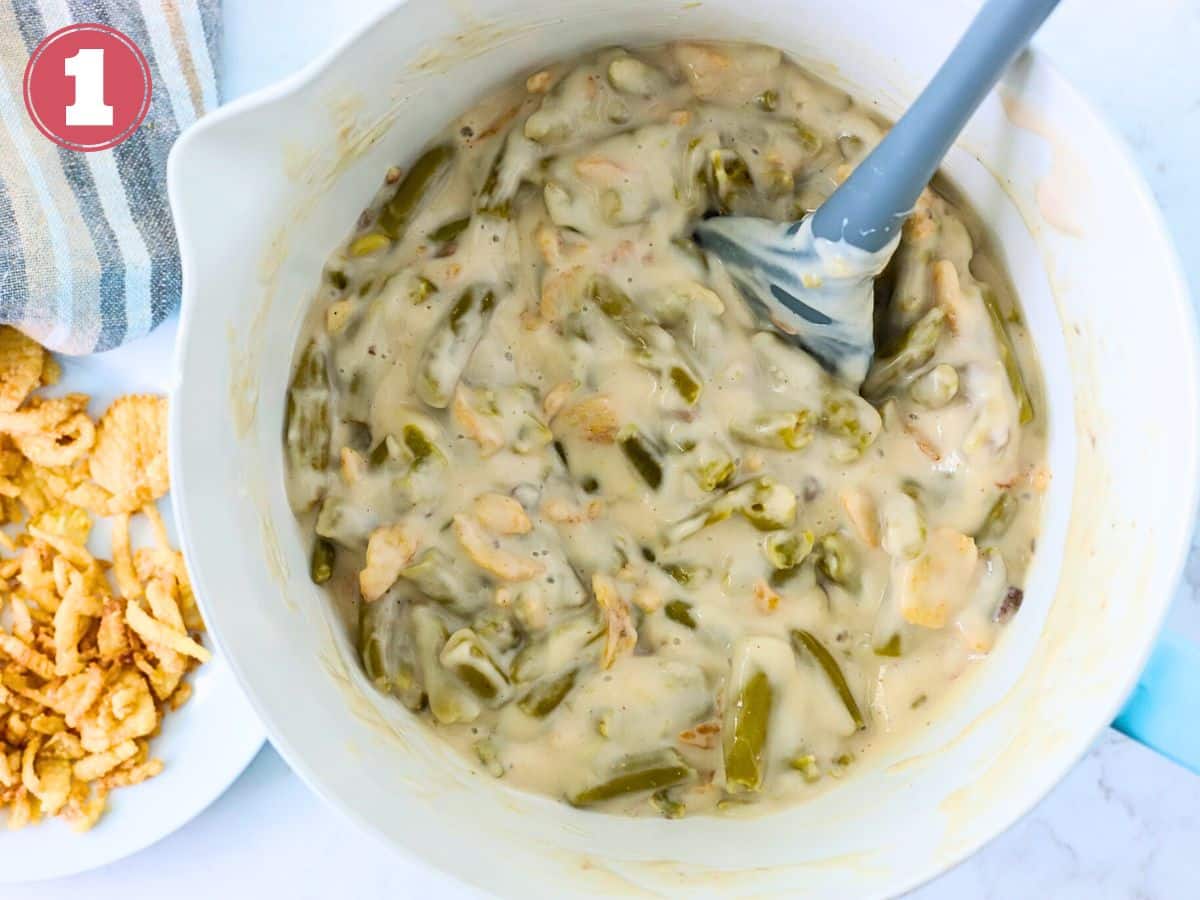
(286, 43, 1049, 816)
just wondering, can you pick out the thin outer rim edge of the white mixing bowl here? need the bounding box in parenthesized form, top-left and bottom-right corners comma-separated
(167, 0, 1200, 896)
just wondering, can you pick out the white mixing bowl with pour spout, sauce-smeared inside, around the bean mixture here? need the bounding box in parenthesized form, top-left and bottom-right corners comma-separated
(170, 0, 1198, 898)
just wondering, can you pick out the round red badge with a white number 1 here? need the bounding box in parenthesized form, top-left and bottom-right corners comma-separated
(25, 23, 151, 152)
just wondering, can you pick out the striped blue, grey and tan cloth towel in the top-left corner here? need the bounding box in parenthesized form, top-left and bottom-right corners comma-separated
(0, 0, 221, 354)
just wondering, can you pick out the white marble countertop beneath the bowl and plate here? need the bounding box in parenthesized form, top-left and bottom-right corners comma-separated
(11, 0, 1200, 900)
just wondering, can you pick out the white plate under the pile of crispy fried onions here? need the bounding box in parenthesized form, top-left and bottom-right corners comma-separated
(0, 320, 263, 884)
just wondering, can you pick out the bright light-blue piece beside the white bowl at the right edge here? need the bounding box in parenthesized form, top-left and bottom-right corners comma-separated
(1112, 632, 1200, 774)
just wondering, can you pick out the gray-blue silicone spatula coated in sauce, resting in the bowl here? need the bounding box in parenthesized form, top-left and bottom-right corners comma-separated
(696, 0, 1058, 389)
